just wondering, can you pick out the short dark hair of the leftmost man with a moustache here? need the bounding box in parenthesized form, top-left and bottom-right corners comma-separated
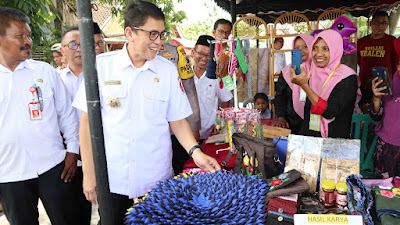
(0, 7, 31, 36)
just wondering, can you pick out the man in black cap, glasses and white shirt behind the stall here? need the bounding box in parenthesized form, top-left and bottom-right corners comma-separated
(193, 35, 233, 140)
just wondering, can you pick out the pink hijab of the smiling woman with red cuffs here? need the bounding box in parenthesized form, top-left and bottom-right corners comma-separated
(309, 30, 361, 137)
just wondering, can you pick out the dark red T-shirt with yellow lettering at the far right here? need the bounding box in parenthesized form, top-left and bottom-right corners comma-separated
(357, 34, 399, 88)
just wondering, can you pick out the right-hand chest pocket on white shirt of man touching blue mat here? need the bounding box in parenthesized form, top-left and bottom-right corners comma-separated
(143, 82, 169, 119)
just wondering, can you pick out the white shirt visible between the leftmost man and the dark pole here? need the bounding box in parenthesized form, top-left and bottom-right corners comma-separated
(59, 65, 83, 121)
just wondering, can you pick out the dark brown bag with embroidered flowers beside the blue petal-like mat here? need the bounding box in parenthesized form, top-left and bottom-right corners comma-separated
(232, 133, 281, 179)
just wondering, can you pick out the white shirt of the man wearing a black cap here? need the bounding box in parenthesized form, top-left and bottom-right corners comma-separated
(193, 69, 233, 139)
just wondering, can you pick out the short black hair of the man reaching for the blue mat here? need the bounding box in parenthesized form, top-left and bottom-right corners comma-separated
(124, 1, 165, 28)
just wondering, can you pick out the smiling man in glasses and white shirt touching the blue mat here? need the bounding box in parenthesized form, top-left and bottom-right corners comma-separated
(73, 1, 221, 225)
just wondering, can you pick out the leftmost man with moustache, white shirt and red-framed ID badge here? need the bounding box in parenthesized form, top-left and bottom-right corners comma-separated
(0, 7, 79, 225)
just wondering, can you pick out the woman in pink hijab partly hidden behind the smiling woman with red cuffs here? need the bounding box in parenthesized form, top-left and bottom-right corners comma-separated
(274, 34, 314, 134)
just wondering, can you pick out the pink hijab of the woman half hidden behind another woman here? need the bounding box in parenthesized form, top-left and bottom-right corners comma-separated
(282, 34, 314, 119)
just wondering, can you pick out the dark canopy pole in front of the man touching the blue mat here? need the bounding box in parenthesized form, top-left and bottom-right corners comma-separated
(77, 0, 113, 225)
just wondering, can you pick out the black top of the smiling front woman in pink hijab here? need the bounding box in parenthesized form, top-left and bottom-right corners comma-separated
(299, 75, 358, 138)
